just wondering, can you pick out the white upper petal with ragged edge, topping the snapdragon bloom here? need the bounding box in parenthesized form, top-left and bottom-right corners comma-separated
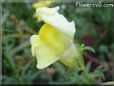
(36, 7, 75, 39)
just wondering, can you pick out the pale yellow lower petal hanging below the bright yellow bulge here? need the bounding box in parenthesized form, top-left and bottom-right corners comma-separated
(35, 43, 60, 69)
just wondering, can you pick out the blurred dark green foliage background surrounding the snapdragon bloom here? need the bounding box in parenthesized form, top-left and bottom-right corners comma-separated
(2, 0, 114, 84)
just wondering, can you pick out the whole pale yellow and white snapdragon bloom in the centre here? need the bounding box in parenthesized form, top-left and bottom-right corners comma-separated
(30, 6, 84, 69)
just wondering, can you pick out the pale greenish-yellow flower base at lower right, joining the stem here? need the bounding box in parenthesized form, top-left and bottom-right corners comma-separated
(59, 43, 84, 70)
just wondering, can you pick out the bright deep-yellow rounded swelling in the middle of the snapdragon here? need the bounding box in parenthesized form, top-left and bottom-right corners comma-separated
(39, 24, 67, 54)
